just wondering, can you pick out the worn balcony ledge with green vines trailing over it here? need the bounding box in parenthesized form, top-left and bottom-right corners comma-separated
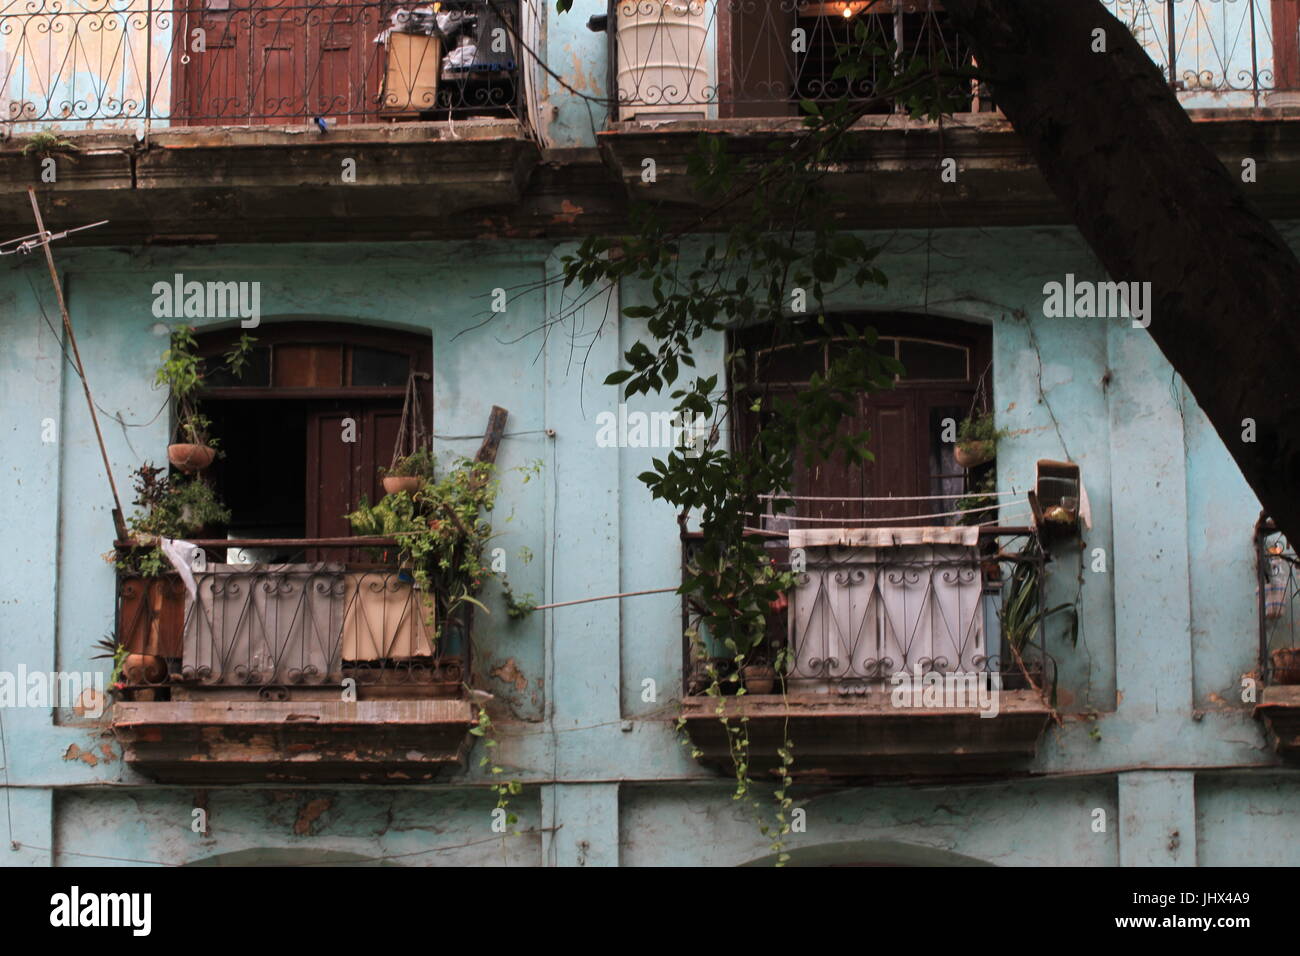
(681, 691, 1052, 779)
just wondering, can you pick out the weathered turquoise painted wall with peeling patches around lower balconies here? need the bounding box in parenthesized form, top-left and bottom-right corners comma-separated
(0, 226, 1300, 865)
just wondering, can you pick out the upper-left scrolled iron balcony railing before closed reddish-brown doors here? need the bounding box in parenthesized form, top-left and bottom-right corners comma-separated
(0, 0, 520, 131)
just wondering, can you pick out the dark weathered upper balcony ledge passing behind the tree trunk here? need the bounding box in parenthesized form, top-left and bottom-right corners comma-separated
(598, 109, 1300, 229)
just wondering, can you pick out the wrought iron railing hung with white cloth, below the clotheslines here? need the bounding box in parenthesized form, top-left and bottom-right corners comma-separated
(683, 527, 1053, 696)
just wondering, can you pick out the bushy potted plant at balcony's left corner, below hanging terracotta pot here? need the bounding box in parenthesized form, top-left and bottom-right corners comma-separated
(117, 462, 230, 578)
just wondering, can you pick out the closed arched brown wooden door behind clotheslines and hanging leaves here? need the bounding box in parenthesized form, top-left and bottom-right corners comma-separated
(733, 316, 992, 529)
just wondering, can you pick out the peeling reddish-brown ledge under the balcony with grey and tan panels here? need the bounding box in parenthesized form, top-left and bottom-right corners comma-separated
(112, 700, 475, 783)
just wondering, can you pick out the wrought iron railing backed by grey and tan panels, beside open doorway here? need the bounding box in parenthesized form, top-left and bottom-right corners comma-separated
(117, 546, 471, 700)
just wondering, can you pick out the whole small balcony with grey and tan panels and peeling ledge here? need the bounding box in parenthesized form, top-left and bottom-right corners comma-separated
(113, 540, 473, 782)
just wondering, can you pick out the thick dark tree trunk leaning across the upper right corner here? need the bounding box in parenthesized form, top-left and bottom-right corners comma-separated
(944, 0, 1300, 541)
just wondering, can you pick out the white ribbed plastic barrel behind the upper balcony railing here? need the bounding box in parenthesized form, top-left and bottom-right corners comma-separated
(615, 0, 710, 121)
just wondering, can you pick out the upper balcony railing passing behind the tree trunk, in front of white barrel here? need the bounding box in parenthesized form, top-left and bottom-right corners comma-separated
(608, 0, 1284, 121)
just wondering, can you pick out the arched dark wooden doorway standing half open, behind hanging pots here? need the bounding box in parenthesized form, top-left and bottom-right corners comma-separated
(196, 323, 433, 561)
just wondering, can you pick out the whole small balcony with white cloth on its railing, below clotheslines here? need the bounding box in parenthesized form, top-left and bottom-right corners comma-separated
(683, 527, 1056, 778)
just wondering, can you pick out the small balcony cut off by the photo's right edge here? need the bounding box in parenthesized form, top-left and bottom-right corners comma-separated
(1255, 518, 1300, 760)
